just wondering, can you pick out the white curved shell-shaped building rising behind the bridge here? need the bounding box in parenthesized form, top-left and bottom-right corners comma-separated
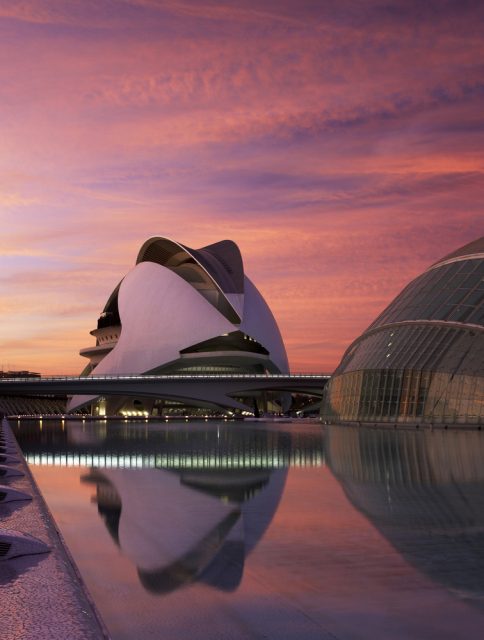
(68, 237, 289, 414)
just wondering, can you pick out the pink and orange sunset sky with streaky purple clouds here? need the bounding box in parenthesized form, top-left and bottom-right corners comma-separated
(0, 0, 484, 374)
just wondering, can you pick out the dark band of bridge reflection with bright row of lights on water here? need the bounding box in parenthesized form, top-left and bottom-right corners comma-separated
(22, 420, 324, 471)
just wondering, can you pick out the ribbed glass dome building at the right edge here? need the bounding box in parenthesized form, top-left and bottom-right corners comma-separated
(321, 237, 484, 425)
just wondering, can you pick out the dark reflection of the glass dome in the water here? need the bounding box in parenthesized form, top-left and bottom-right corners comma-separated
(325, 425, 484, 606)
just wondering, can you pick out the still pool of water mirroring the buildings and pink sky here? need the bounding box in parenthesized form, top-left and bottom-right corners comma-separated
(12, 420, 484, 640)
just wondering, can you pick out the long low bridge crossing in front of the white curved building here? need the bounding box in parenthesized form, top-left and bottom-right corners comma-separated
(0, 373, 330, 409)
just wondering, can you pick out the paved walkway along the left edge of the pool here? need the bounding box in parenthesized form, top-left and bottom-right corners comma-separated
(0, 420, 109, 640)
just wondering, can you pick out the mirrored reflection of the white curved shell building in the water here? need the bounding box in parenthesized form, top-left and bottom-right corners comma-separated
(84, 469, 286, 593)
